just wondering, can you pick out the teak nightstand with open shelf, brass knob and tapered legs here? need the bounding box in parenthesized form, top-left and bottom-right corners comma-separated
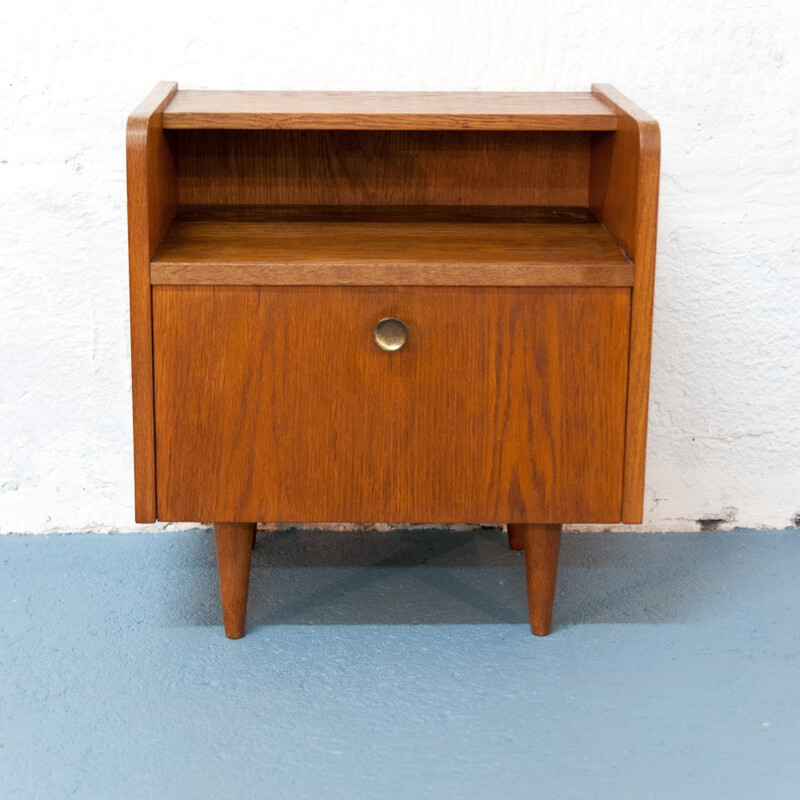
(127, 83, 660, 638)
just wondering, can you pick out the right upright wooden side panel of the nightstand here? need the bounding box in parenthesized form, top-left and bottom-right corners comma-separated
(589, 86, 661, 524)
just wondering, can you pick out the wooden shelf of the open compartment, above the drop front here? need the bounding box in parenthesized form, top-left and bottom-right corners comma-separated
(151, 208, 633, 286)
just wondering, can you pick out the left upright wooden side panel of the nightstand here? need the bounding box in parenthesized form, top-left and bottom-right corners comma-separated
(126, 83, 177, 522)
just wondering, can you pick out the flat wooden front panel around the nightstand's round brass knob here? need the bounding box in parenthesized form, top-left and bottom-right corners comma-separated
(153, 286, 630, 522)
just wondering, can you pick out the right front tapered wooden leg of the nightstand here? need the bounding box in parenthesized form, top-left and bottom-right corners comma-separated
(515, 525, 561, 636)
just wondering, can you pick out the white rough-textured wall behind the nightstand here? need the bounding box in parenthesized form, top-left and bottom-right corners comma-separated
(0, 0, 800, 532)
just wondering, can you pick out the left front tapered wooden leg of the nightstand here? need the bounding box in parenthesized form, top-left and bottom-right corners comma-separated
(214, 522, 256, 639)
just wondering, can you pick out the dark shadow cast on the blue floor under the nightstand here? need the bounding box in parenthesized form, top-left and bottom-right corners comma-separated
(164, 528, 752, 634)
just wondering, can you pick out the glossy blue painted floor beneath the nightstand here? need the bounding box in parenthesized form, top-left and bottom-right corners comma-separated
(0, 529, 800, 800)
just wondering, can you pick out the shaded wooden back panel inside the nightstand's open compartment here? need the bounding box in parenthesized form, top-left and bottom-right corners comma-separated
(168, 130, 591, 207)
